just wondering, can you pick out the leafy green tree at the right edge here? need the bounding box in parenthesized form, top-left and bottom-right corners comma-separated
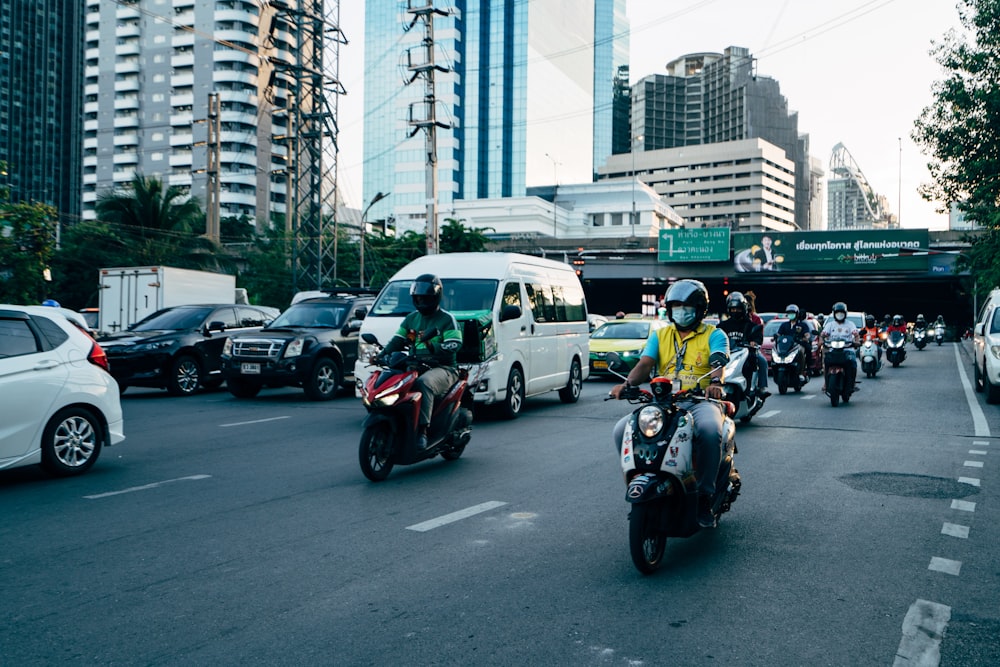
(912, 0, 1000, 291)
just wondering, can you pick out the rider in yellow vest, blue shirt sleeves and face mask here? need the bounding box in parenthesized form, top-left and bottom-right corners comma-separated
(609, 280, 729, 528)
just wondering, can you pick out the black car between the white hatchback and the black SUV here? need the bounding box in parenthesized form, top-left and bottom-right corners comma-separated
(98, 304, 279, 396)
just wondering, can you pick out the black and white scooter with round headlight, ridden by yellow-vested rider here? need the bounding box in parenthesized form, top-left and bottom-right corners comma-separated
(605, 352, 741, 574)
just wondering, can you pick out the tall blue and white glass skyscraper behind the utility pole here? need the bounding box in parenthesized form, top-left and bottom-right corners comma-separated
(363, 0, 628, 231)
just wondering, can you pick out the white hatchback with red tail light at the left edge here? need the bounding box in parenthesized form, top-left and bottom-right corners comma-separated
(0, 304, 125, 477)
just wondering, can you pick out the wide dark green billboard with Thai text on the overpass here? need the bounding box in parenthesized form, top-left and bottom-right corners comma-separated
(732, 229, 930, 273)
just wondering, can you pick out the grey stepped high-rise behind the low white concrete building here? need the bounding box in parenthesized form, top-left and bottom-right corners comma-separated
(632, 46, 820, 229)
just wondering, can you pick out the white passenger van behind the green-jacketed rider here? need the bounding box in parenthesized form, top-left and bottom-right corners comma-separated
(354, 252, 590, 419)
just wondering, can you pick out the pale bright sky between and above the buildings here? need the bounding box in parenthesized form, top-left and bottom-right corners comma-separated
(338, 0, 960, 229)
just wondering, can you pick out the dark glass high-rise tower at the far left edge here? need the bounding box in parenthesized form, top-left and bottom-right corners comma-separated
(0, 0, 83, 218)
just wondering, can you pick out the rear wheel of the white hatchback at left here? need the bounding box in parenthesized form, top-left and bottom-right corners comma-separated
(41, 407, 104, 477)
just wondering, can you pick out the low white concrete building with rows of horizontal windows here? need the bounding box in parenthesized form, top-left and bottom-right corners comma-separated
(599, 139, 798, 231)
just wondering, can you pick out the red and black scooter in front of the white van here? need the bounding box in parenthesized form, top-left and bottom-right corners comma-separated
(358, 330, 473, 482)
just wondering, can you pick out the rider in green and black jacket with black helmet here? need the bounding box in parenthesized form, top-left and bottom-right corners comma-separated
(376, 273, 462, 449)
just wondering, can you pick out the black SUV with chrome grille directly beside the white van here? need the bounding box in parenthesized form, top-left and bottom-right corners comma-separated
(222, 289, 375, 401)
